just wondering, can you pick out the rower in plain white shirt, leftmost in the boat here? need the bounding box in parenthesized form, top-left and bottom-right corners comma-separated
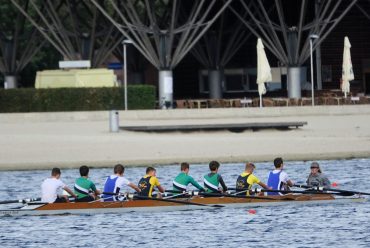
(41, 168, 77, 203)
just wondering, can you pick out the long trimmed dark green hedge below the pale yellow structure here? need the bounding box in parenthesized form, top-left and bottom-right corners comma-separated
(0, 85, 156, 113)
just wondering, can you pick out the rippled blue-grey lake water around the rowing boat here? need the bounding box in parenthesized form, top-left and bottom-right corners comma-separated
(0, 159, 370, 247)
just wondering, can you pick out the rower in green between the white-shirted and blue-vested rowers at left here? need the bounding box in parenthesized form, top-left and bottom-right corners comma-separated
(74, 165, 100, 202)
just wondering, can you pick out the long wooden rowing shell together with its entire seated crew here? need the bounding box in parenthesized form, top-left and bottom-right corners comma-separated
(0, 158, 370, 216)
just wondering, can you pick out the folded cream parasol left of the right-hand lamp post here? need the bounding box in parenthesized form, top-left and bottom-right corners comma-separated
(257, 38, 272, 108)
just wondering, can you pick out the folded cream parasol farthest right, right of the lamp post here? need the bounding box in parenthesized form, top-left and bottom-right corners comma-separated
(342, 36, 355, 97)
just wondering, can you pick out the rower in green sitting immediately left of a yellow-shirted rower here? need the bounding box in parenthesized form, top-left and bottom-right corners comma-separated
(203, 161, 227, 193)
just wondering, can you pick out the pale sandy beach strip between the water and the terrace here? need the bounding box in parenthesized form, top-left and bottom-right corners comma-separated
(0, 105, 370, 170)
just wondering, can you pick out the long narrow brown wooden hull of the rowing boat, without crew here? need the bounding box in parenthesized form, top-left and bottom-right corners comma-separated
(0, 194, 366, 216)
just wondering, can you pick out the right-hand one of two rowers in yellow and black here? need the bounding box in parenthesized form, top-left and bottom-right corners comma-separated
(236, 162, 272, 195)
